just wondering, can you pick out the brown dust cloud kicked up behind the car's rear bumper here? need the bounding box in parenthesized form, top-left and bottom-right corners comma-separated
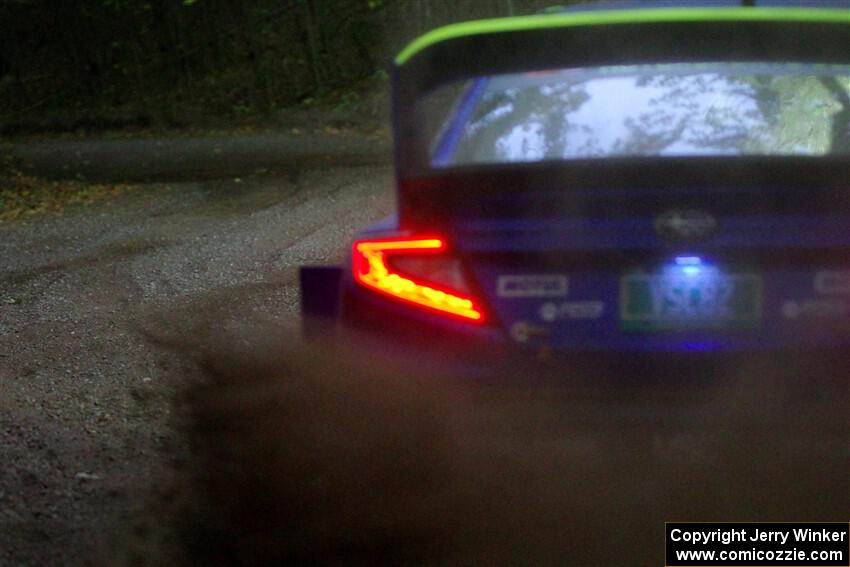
(156, 329, 850, 565)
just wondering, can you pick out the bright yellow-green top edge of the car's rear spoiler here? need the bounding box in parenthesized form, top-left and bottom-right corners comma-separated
(394, 7, 850, 66)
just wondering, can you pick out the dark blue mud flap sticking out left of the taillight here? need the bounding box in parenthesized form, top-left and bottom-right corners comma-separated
(299, 266, 342, 340)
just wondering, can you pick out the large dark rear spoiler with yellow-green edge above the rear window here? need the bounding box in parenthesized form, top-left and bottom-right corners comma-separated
(392, 7, 850, 179)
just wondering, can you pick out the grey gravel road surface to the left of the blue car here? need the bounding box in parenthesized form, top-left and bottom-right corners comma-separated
(0, 163, 393, 566)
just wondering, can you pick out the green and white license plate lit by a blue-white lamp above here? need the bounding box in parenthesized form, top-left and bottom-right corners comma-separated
(620, 271, 762, 331)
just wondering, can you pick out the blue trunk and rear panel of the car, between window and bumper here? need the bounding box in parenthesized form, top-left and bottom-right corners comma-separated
(386, 158, 850, 351)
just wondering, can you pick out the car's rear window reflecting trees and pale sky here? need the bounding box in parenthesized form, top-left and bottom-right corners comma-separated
(423, 63, 850, 167)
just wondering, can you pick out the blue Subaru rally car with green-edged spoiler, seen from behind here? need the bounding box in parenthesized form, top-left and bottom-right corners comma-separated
(301, 1, 850, 366)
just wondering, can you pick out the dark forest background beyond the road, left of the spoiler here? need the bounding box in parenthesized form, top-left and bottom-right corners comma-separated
(0, 0, 564, 134)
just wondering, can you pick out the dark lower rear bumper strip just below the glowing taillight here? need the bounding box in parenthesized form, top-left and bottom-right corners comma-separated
(338, 282, 850, 388)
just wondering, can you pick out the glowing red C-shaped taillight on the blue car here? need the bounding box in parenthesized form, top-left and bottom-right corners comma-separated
(352, 238, 483, 322)
